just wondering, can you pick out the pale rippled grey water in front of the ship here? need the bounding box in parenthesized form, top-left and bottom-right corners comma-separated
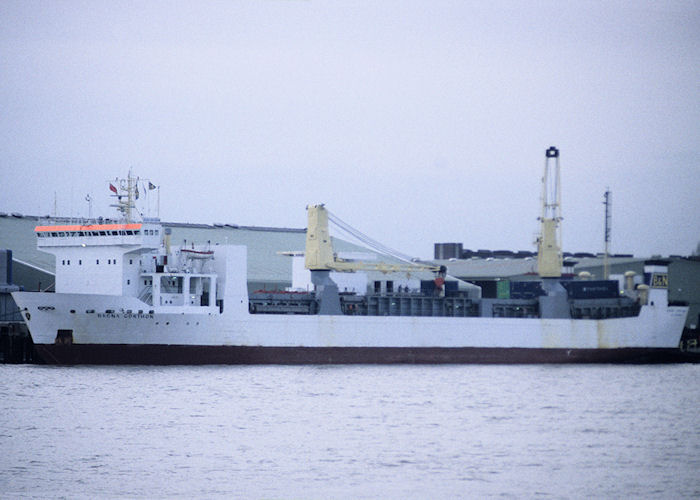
(0, 365, 700, 498)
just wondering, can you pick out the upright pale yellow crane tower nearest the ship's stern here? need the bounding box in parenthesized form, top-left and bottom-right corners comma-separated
(537, 146, 563, 278)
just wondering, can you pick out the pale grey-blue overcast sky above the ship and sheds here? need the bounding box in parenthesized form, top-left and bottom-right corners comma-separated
(0, 0, 700, 257)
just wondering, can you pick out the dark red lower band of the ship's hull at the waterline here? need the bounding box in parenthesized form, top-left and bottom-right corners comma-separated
(36, 344, 694, 365)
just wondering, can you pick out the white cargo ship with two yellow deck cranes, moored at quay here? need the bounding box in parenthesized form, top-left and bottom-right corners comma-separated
(12, 148, 688, 364)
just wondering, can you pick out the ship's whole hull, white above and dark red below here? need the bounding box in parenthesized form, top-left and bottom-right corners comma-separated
(13, 292, 687, 364)
